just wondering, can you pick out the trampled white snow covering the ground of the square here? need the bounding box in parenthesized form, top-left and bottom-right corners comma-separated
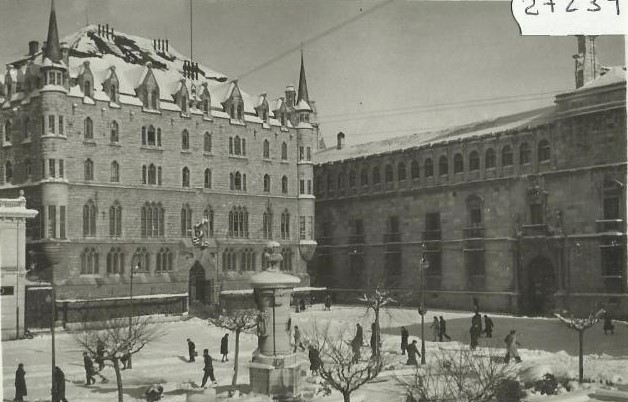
(2, 305, 628, 402)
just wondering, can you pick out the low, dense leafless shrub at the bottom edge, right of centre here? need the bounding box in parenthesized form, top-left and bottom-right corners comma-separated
(397, 348, 513, 402)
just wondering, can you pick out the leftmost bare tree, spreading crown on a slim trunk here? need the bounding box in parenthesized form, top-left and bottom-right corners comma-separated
(74, 317, 162, 402)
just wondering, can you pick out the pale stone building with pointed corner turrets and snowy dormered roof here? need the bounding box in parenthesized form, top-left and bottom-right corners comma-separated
(0, 5, 318, 322)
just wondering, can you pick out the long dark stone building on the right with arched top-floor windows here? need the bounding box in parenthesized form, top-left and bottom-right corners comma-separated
(312, 37, 628, 316)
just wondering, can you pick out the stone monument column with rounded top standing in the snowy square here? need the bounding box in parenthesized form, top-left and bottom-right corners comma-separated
(249, 241, 301, 397)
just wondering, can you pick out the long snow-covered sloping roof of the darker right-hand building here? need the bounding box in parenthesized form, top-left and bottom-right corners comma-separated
(314, 106, 556, 164)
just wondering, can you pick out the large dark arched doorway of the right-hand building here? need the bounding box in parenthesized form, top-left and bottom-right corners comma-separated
(527, 256, 557, 315)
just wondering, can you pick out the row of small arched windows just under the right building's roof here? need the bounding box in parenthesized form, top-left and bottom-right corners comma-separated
(327, 140, 551, 191)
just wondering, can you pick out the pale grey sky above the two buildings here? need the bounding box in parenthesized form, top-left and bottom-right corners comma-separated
(0, 0, 626, 146)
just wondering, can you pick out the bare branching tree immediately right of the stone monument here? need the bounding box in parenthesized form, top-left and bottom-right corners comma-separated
(306, 323, 384, 402)
